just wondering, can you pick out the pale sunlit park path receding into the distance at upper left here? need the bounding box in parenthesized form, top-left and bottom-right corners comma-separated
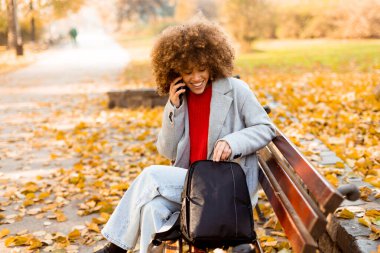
(0, 8, 129, 180)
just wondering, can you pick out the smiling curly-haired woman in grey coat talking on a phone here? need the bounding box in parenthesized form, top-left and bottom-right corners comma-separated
(98, 20, 275, 253)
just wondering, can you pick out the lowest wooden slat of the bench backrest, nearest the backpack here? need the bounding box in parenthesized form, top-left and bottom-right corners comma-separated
(259, 161, 317, 253)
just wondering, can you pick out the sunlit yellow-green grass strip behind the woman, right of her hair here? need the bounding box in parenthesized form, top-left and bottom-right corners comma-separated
(236, 40, 380, 71)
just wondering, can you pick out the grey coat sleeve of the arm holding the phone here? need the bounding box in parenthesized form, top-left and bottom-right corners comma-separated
(156, 100, 186, 160)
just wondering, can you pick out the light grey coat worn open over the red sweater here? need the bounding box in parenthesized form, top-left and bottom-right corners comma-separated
(157, 77, 275, 205)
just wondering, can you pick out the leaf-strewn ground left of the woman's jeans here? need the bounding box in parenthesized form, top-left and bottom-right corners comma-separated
(0, 97, 168, 252)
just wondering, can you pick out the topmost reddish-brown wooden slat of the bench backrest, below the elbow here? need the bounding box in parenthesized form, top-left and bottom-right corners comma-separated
(273, 129, 343, 213)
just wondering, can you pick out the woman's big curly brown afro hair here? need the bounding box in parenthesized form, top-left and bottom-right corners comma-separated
(151, 19, 235, 95)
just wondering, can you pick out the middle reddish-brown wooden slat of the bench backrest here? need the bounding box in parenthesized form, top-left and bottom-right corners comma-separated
(259, 148, 327, 239)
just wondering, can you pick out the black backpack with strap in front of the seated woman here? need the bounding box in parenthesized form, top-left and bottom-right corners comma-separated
(152, 160, 256, 249)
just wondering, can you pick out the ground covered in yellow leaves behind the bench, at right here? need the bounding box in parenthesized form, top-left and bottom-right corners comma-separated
(242, 70, 380, 246)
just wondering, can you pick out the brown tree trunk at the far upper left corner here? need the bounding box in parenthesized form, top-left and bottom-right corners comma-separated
(5, 0, 24, 55)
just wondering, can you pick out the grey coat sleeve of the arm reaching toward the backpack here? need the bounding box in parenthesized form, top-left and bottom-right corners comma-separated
(218, 90, 275, 160)
